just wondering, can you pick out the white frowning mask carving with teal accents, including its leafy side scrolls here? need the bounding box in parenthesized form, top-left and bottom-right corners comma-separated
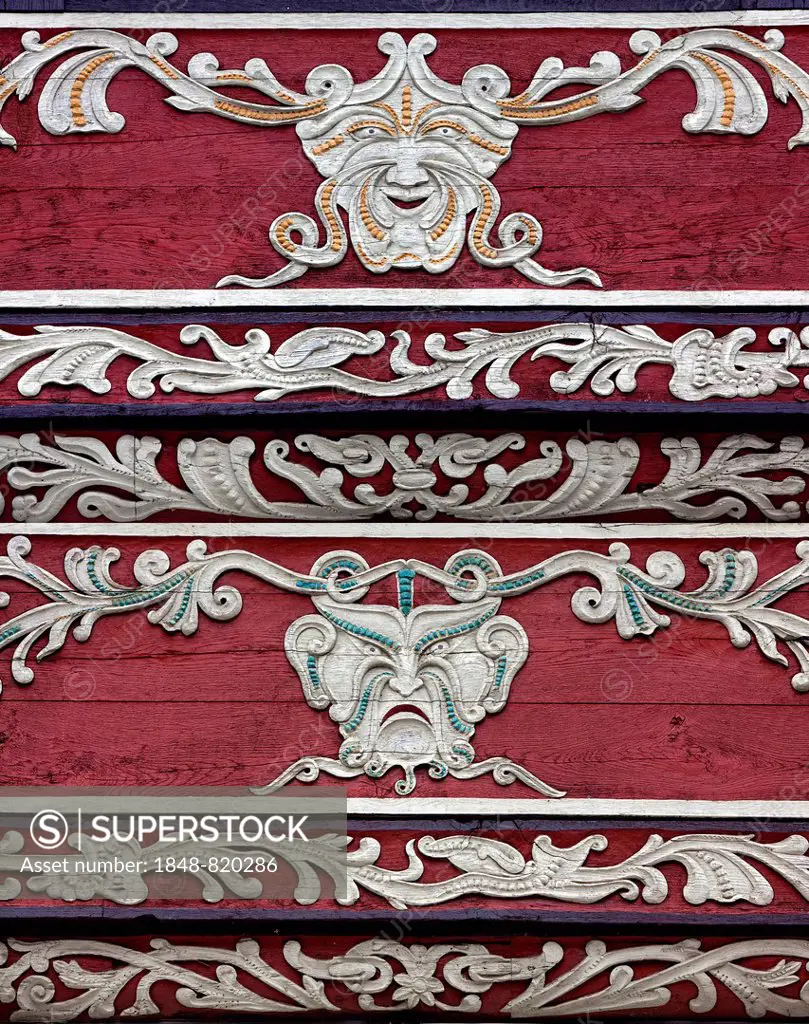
(0, 537, 809, 797)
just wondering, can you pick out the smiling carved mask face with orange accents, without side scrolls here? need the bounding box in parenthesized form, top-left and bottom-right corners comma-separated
(299, 81, 517, 273)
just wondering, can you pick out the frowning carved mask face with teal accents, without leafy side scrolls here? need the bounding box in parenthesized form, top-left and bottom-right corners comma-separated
(286, 585, 527, 795)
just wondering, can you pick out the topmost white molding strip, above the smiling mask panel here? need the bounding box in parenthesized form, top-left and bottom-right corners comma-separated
(0, 10, 809, 32)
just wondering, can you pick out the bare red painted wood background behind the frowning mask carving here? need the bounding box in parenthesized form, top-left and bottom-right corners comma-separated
(0, 537, 809, 800)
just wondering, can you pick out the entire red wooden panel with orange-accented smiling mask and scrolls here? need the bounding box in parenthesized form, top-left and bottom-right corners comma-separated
(0, 12, 809, 296)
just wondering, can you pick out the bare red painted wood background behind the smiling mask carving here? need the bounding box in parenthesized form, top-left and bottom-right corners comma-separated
(0, 24, 809, 294)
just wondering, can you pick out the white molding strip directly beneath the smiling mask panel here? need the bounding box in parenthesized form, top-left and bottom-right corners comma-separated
(0, 288, 809, 309)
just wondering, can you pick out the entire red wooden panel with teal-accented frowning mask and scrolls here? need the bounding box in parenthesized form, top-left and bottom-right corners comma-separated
(0, 524, 809, 805)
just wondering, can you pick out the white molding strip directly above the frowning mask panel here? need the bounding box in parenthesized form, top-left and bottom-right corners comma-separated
(0, 521, 809, 540)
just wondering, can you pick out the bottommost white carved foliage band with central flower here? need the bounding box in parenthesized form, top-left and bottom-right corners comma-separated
(0, 937, 809, 1024)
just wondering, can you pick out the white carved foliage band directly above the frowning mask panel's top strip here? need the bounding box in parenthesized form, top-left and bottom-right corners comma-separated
(0, 433, 809, 522)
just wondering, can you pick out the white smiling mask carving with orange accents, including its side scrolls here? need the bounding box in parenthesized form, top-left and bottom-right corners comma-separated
(0, 29, 809, 288)
